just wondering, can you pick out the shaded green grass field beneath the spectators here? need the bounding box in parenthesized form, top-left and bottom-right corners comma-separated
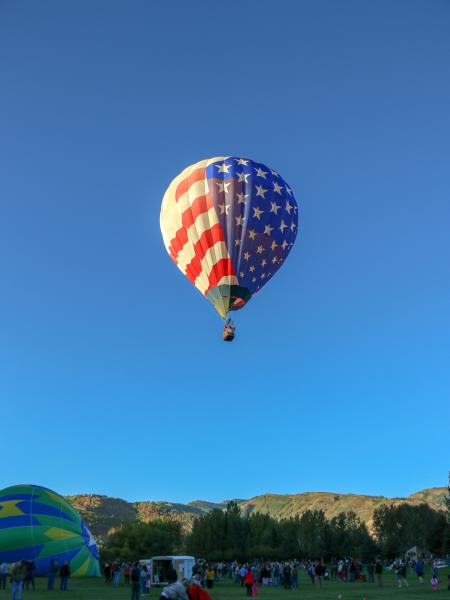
(5, 569, 450, 600)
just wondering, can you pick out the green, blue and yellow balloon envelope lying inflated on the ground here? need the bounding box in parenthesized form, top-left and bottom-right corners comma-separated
(0, 485, 100, 577)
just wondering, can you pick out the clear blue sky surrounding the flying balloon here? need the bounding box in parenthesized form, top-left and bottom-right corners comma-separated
(0, 0, 450, 501)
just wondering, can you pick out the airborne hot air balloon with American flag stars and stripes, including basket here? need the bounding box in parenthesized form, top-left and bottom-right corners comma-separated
(160, 156, 298, 341)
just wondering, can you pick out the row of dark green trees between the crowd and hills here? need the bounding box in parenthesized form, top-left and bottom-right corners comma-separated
(102, 492, 450, 561)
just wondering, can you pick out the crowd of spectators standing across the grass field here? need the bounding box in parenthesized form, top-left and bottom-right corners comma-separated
(0, 558, 444, 600)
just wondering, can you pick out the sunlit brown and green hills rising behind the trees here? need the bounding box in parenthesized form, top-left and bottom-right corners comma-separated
(67, 487, 447, 544)
